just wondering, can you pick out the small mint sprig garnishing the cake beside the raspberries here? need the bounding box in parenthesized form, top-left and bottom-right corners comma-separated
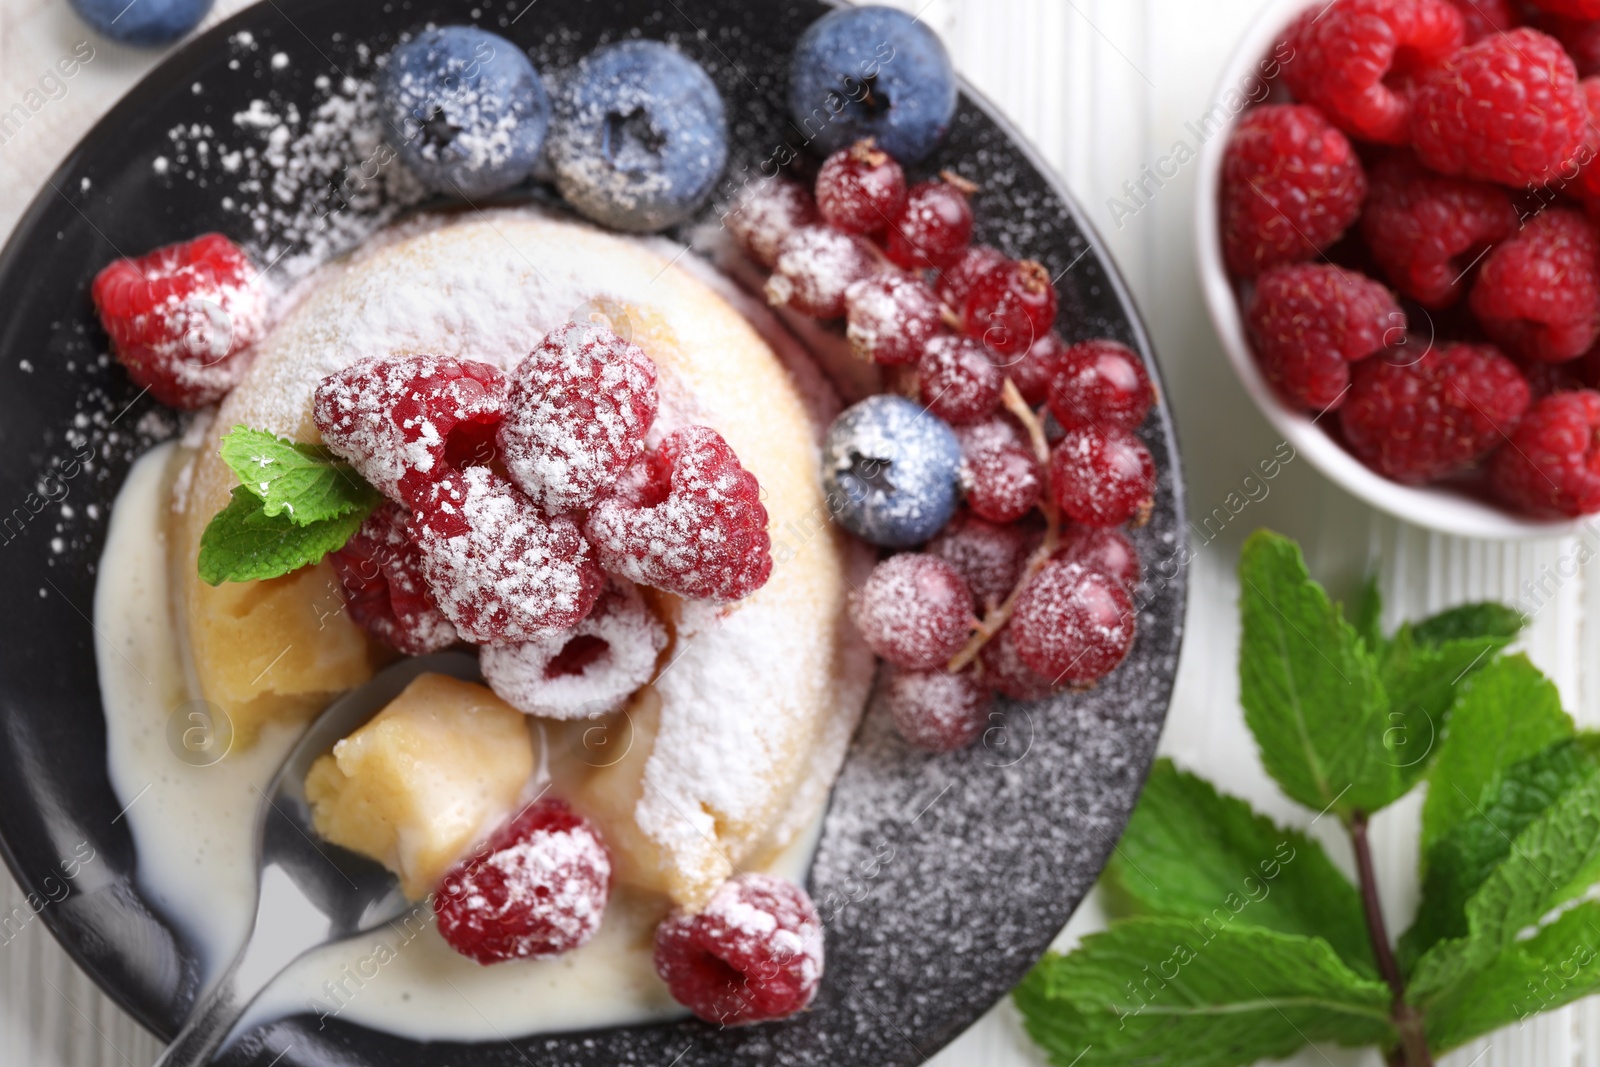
(198, 426, 382, 585)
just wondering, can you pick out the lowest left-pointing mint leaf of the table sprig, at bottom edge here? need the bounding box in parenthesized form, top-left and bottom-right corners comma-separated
(1013, 918, 1394, 1067)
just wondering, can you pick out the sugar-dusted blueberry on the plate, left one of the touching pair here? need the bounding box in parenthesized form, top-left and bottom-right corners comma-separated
(378, 26, 550, 200)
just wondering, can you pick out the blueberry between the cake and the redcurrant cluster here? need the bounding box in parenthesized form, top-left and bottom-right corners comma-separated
(822, 394, 962, 549)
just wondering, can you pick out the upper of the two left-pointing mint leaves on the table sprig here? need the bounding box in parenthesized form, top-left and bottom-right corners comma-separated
(1107, 760, 1378, 977)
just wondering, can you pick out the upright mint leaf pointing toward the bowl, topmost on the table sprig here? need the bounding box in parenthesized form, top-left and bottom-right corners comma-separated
(1238, 530, 1403, 814)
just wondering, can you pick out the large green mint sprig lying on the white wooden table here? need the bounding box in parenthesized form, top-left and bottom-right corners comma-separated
(1016, 531, 1600, 1067)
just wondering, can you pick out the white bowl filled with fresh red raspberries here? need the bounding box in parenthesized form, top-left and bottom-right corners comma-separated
(1195, 0, 1600, 537)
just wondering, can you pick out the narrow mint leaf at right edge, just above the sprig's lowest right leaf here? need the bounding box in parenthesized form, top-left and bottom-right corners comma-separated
(1408, 763, 1600, 1006)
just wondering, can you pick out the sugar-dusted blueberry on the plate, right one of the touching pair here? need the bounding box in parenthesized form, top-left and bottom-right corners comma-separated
(550, 40, 728, 234)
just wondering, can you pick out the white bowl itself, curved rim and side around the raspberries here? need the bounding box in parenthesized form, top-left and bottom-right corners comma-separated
(1195, 0, 1587, 539)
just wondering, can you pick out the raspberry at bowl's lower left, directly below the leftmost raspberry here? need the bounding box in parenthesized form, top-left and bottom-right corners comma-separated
(1245, 264, 1405, 411)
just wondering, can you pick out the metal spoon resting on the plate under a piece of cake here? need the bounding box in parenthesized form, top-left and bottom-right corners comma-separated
(155, 653, 480, 1067)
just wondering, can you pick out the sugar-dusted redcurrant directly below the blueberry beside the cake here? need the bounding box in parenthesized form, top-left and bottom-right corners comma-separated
(850, 552, 973, 670)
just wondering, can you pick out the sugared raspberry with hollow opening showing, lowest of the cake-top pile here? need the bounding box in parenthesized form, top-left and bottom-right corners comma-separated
(478, 577, 667, 718)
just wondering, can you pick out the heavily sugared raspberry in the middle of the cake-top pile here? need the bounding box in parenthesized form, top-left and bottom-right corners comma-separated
(411, 467, 603, 645)
